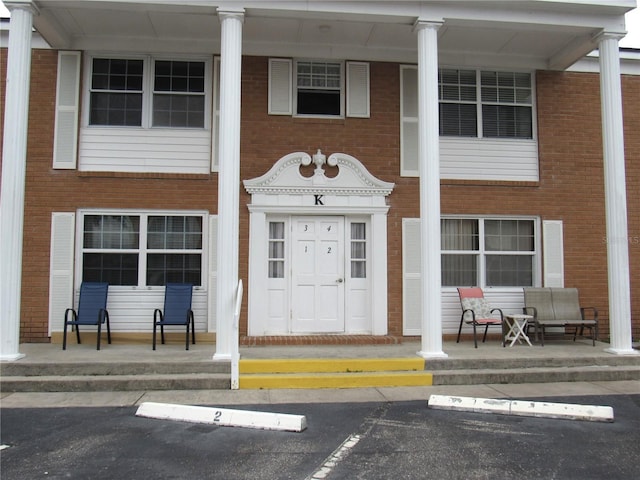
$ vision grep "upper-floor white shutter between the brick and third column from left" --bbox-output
[400,65,420,177]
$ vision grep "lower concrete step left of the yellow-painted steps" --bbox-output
[1,373,231,392]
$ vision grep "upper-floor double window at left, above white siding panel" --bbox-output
[88,57,211,128]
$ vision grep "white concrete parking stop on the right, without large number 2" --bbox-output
[428,395,613,422]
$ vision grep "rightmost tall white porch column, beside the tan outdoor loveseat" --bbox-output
[598,33,638,355]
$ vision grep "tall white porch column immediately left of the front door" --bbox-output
[212,9,244,360]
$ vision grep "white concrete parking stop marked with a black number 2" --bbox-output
[136,402,307,432]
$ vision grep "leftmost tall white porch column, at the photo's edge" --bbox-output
[0,1,37,361]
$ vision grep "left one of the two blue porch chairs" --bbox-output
[62,282,111,350]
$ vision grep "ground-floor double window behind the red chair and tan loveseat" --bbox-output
[440,218,536,287]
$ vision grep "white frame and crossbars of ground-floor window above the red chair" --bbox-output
[440,215,543,290]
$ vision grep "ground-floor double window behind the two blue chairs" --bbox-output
[81,213,204,286]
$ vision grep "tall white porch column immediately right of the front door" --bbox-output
[415,20,447,358]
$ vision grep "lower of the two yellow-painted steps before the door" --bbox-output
[240,371,433,390]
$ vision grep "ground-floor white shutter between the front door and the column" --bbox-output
[402,218,422,336]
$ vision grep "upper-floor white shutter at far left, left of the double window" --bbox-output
[53,51,80,169]
